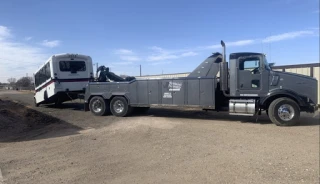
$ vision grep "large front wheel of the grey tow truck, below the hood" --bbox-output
[268,98,300,126]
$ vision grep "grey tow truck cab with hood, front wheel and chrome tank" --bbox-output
[221,49,318,125]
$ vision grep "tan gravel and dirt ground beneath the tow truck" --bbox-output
[0,91,319,184]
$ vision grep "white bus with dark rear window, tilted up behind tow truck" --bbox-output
[34,54,93,106]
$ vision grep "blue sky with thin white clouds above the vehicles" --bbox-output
[0,0,319,82]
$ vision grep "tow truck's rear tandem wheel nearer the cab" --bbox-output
[110,96,132,117]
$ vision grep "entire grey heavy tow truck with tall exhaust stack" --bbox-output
[84,41,318,126]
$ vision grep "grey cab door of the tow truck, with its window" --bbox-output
[237,55,269,96]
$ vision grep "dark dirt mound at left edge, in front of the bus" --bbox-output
[0,100,65,141]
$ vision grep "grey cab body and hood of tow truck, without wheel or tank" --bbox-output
[230,53,318,112]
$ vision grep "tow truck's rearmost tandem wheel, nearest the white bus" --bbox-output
[89,96,109,116]
